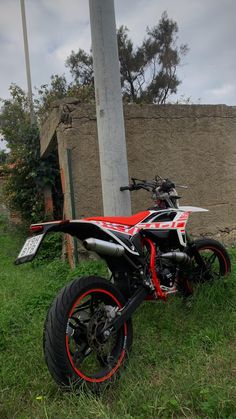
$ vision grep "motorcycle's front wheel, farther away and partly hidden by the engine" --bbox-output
[181,239,231,296]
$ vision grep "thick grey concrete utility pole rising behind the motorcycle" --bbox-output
[89,0,131,215]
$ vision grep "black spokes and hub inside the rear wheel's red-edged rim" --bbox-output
[68,292,125,377]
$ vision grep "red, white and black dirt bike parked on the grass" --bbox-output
[16,177,230,390]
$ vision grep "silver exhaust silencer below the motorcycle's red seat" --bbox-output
[83,237,125,257]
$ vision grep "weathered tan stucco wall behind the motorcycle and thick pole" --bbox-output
[40,101,236,243]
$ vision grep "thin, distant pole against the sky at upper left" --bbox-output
[20,0,35,125]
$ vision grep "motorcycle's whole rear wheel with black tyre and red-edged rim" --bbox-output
[43,276,132,391]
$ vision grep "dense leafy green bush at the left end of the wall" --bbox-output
[1,84,59,222]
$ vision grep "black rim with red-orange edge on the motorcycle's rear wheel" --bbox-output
[66,289,127,382]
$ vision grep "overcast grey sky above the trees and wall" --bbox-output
[0,0,236,105]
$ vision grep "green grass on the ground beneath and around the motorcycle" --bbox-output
[0,225,236,419]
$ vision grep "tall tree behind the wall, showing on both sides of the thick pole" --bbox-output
[66,12,188,103]
